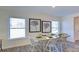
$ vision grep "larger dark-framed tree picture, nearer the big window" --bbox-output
[29,18,41,32]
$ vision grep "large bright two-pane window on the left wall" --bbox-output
[10,18,25,39]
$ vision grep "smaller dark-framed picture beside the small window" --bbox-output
[42,21,51,33]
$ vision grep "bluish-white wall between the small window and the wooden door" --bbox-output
[62,13,79,42]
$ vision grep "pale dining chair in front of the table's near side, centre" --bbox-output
[45,38,59,52]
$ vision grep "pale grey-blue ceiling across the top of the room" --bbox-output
[0,6,79,16]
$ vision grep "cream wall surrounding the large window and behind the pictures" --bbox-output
[0,10,60,49]
